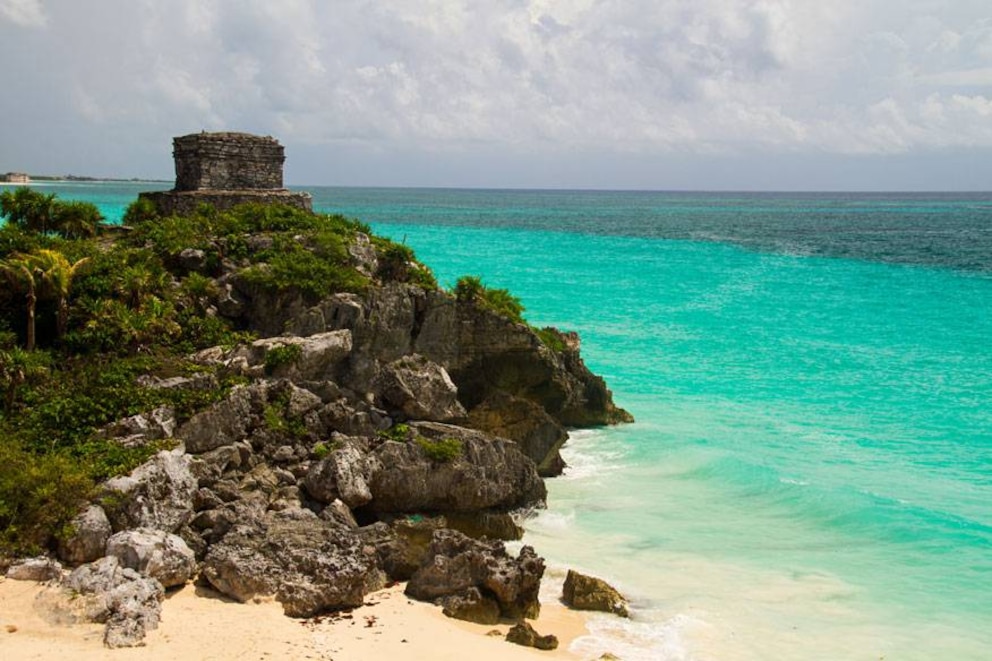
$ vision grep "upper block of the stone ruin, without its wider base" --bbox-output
[172,133,286,191]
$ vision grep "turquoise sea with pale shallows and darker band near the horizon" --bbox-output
[15,184,992,661]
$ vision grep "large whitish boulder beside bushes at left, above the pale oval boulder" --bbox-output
[101,450,197,532]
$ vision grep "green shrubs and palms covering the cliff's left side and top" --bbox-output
[0,188,433,553]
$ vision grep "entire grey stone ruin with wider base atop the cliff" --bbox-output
[138,131,311,216]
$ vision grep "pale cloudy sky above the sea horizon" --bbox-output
[0,0,992,190]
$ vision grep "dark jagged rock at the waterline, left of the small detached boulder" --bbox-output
[406,529,544,619]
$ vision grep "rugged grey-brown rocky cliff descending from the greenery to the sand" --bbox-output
[3,202,630,645]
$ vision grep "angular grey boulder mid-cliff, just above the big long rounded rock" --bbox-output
[376,354,465,422]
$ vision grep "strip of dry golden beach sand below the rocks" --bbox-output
[0,579,586,661]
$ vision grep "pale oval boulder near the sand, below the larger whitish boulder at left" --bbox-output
[107,530,196,588]
